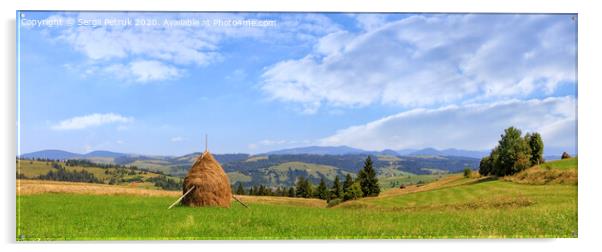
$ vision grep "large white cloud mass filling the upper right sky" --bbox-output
[261,15,576,113]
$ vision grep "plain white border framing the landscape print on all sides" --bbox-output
[0,0,602,252]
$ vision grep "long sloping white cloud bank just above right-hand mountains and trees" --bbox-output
[320,97,577,150]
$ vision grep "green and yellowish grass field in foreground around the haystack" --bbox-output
[17,160,577,240]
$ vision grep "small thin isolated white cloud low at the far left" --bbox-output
[52,113,134,130]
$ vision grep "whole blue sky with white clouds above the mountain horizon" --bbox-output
[19,12,577,155]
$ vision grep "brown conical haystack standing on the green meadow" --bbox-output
[182,151,232,207]
